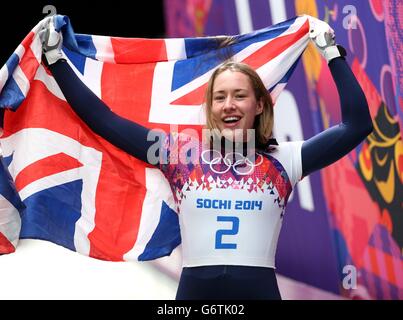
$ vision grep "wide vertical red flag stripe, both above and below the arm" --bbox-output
[88,60,155,260]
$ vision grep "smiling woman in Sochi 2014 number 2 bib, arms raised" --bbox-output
[42,16,372,299]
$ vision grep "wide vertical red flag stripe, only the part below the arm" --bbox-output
[88,160,146,261]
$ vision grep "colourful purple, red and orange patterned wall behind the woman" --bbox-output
[165,0,403,299]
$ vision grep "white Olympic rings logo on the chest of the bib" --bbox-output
[201,150,263,175]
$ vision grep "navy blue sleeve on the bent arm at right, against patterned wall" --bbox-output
[301,57,373,176]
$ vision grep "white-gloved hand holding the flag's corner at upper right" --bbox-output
[309,17,346,63]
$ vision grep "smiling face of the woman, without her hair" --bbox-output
[211,69,263,141]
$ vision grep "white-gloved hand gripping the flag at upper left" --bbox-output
[39,16,64,65]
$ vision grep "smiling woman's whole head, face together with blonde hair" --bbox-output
[204,61,274,149]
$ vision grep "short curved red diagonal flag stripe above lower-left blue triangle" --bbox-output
[15,153,82,191]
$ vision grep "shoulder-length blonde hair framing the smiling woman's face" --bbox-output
[204,61,274,148]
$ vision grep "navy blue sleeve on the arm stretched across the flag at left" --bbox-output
[49,60,164,165]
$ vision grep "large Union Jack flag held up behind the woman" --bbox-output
[0,16,309,261]
